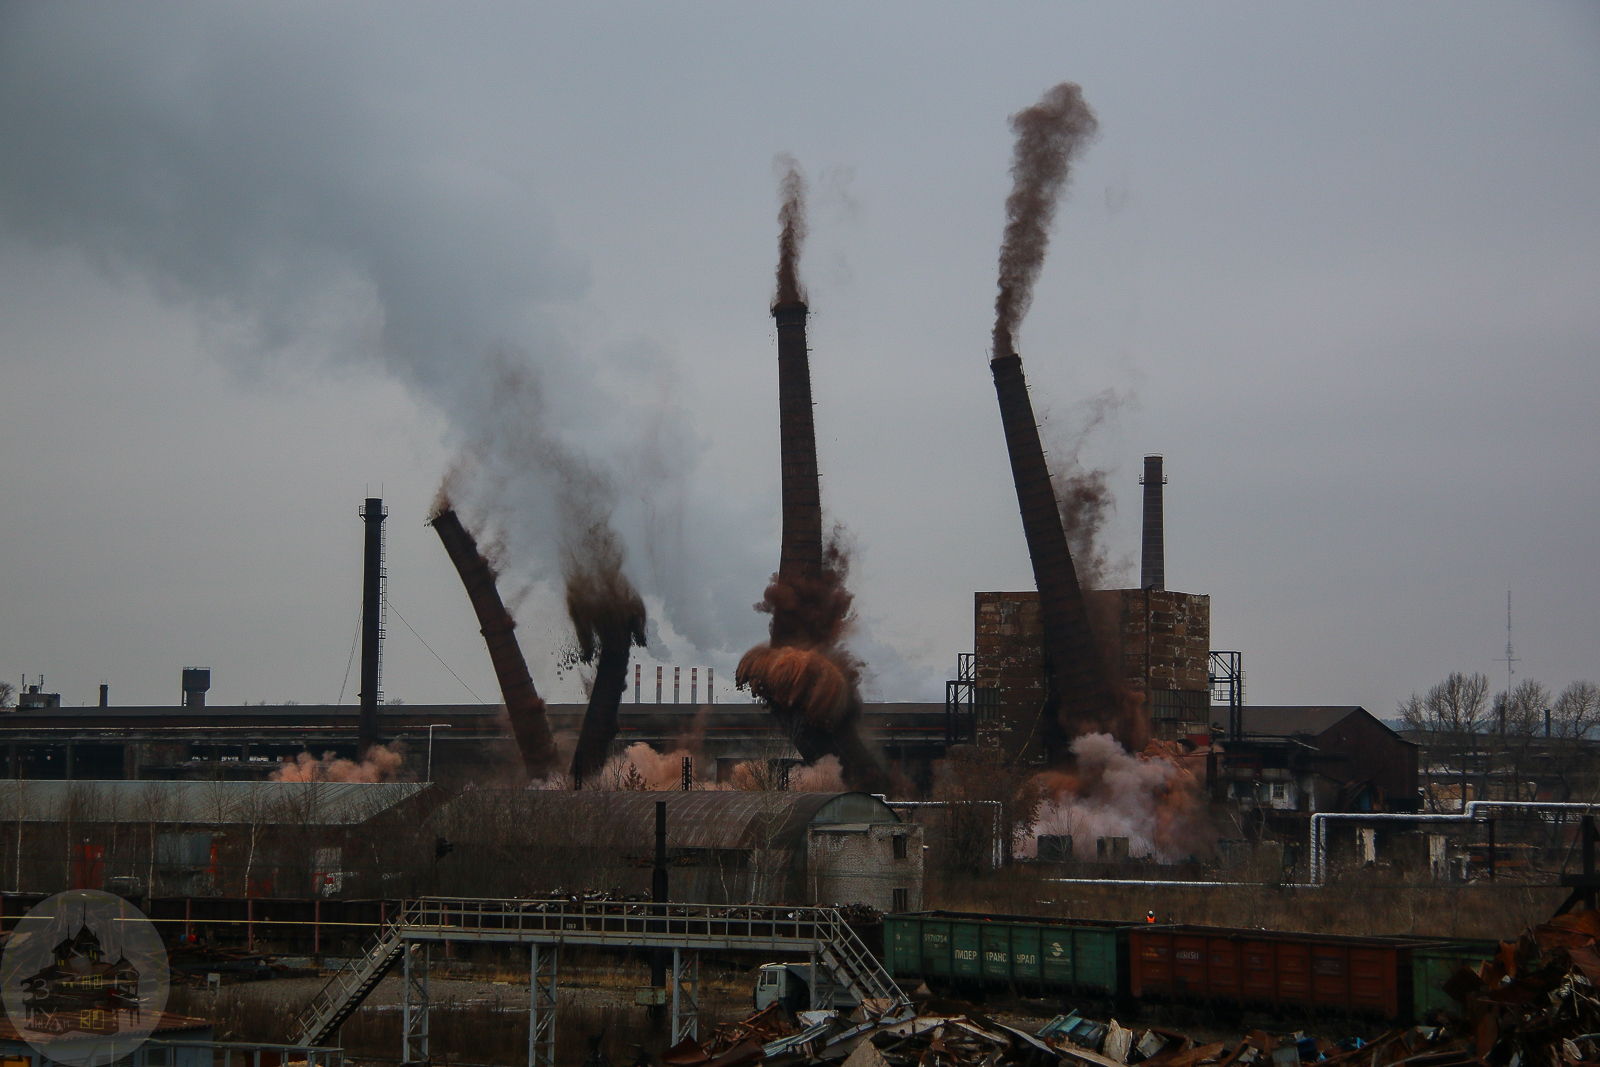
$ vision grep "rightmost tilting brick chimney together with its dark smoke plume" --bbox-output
[989,83,1117,763]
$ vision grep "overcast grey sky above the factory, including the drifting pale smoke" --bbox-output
[0,3,1600,715]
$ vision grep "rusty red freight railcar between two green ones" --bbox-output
[1128,926,1419,1019]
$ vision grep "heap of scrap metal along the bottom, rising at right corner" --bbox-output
[662,910,1600,1067]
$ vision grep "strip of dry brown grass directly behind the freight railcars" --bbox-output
[925,867,1566,939]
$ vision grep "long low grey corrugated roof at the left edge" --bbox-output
[0,779,427,825]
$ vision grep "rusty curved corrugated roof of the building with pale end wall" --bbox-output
[464,789,901,853]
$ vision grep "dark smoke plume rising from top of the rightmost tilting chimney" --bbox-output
[994,82,1099,355]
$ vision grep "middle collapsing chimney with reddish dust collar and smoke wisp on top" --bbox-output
[734,160,890,790]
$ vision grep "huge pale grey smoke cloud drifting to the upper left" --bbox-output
[0,5,770,684]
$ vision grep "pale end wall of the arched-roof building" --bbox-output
[806,822,922,912]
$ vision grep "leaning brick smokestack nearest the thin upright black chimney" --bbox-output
[432,506,555,777]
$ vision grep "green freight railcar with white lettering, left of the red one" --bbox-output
[883,912,1126,997]
